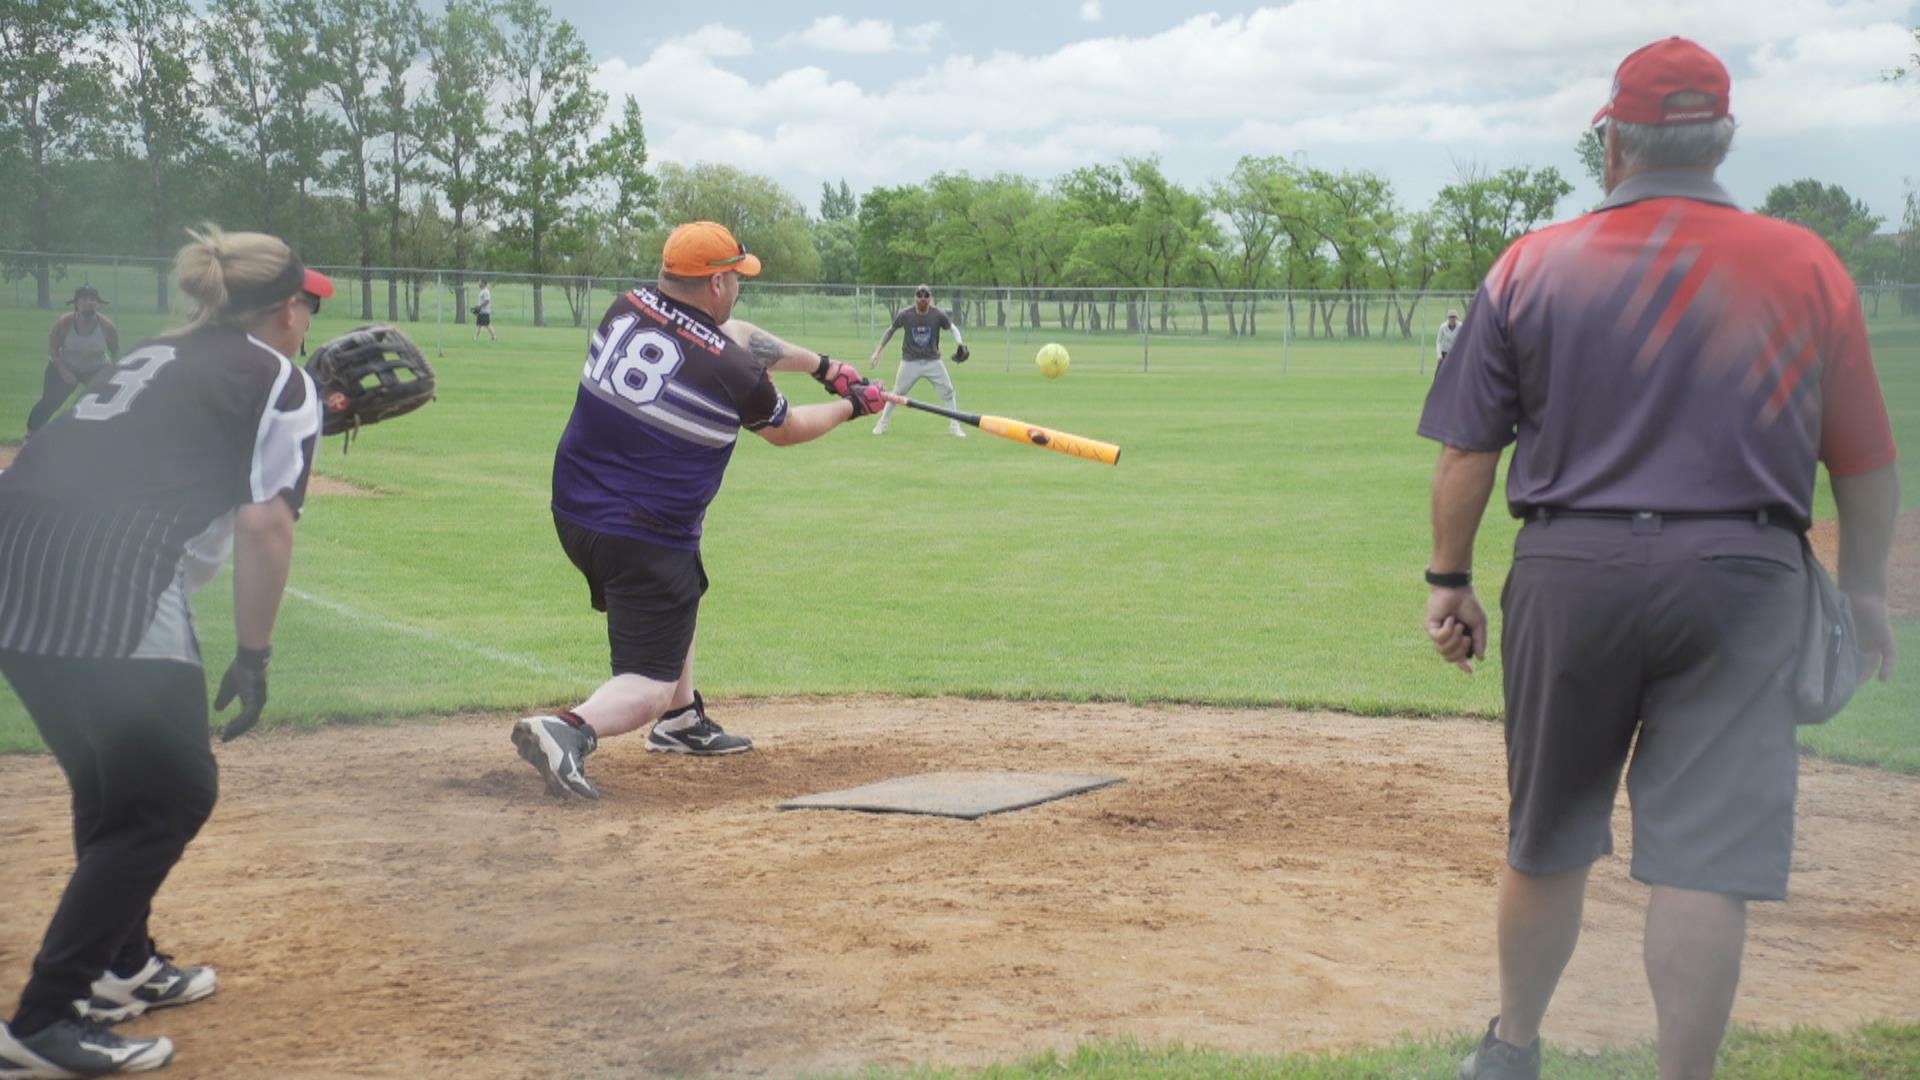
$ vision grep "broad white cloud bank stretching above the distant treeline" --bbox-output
[597,0,1920,220]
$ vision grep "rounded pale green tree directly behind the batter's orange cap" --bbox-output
[649,163,820,281]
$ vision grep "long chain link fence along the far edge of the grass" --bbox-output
[0,250,1920,369]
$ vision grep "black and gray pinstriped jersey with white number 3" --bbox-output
[0,327,321,663]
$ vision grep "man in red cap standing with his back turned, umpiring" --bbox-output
[1419,38,1899,1080]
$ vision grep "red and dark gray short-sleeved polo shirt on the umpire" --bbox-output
[1419,171,1895,523]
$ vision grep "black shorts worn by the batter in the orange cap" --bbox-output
[553,515,707,682]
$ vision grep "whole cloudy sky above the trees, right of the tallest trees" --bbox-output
[551,0,1920,221]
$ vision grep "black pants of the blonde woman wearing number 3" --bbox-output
[0,653,219,1036]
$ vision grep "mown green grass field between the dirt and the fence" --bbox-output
[0,297,1920,760]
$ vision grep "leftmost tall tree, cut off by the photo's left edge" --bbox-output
[0,0,109,307]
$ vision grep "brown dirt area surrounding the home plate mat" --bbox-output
[0,700,1920,1078]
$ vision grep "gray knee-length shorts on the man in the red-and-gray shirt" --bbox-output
[1500,517,1805,899]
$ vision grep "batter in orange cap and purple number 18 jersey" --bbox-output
[513,221,883,799]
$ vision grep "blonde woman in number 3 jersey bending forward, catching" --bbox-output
[0,227,334,1076]
